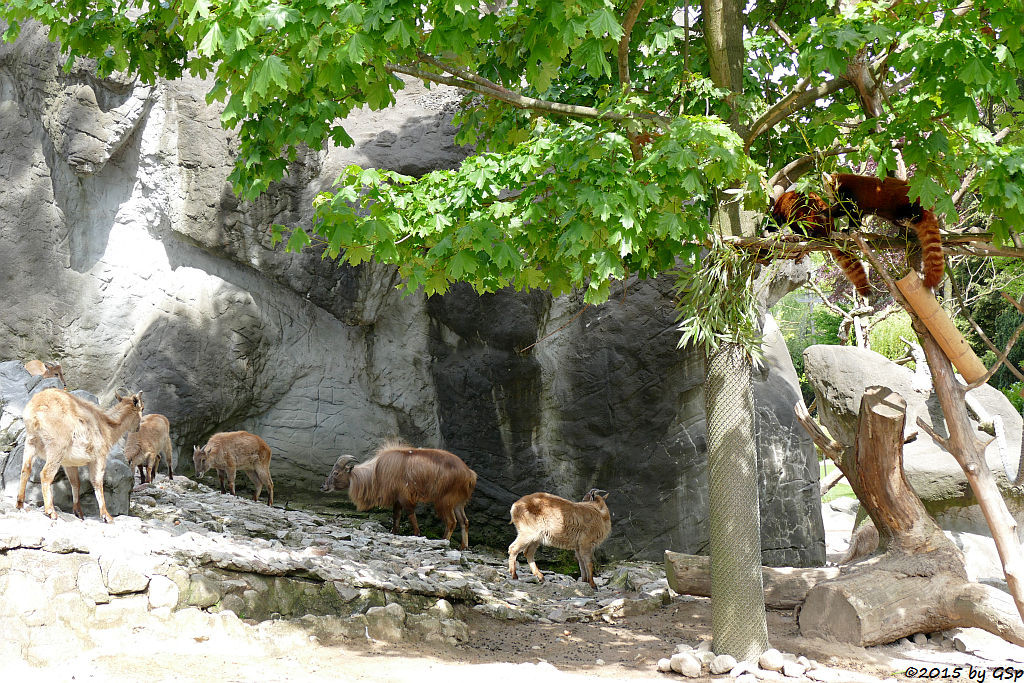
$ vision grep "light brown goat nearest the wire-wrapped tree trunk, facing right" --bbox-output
[509,488,611,588]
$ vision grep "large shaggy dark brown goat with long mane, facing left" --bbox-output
[321,442,476,550]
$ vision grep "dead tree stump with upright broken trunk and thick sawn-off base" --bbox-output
[800,387,1024,645]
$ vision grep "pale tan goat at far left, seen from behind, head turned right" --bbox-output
[16,389,143,522]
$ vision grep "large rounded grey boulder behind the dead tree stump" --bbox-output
[804,345,1024,535]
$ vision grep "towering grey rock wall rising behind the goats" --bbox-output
[0,25,824,565]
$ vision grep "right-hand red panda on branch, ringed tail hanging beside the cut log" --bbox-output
[826,173,945,289]
